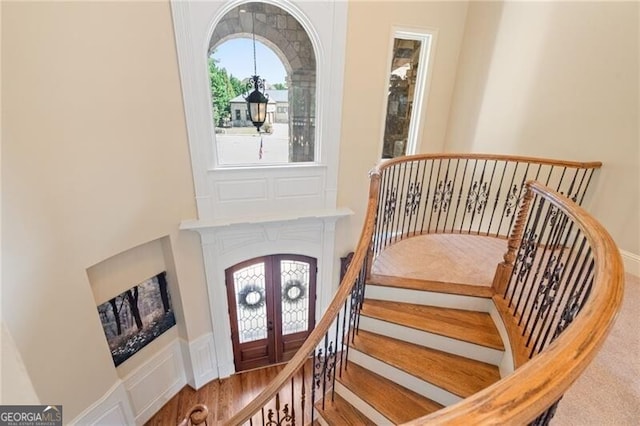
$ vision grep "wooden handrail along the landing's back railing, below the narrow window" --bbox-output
[374,153,602,173]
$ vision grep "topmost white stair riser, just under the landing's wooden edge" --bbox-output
[365,284,493,312]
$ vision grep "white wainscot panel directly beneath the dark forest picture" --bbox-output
[123,339,187,425]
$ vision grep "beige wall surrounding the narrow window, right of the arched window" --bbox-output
[336,1,467,256]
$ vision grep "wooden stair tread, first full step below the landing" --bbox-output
[361,299,504,350]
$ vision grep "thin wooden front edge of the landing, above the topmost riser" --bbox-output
[367,275,493,298]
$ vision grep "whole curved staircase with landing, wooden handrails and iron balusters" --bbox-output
[221,154,624,426]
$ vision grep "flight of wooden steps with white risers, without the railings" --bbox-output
[315,276,504,425]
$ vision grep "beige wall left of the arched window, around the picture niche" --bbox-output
[2,2,210,420]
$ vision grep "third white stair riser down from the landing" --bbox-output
[347,348,462,406]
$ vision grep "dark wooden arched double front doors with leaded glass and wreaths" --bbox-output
[225,254,316,371]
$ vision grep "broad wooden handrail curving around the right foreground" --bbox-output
[406,182,624,425]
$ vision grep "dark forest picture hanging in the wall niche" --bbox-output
[98,271,176,367]
